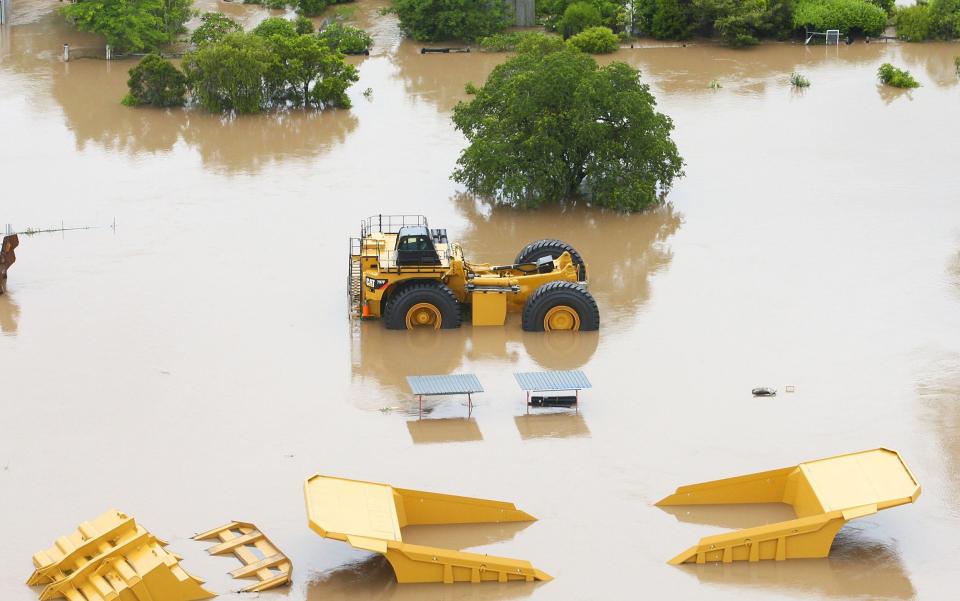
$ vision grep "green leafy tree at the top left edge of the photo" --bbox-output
[60,0,192,52]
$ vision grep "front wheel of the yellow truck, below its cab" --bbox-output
[384,282,460,330]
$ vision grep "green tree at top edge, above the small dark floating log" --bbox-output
[389,0,513,42]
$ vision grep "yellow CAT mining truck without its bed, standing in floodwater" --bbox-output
[347,215,600,332]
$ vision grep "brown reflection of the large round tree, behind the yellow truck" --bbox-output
[454,194,683,326]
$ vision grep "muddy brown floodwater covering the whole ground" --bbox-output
[0,0,960,601]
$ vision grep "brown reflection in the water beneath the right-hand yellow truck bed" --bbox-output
[678,526,916,599]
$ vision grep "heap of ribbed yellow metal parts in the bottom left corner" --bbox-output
[27,510,215,601]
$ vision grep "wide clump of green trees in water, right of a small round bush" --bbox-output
[174,17,357,113]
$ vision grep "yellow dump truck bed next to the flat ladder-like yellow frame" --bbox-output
[305,475,551,583]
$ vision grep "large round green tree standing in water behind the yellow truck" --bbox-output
[453,35,683,211]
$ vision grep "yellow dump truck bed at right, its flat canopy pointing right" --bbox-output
[657,449,920,564]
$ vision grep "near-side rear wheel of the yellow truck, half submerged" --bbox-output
[523,282,600,332]
